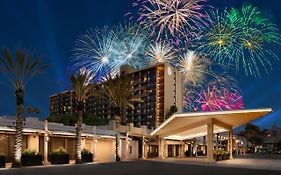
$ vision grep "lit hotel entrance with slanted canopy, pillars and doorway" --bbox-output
[151,108,272,162]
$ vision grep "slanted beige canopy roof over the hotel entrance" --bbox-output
[151,108,272,140]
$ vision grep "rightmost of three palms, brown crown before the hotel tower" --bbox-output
[94,75,143,161]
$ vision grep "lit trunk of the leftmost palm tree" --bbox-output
[13,90,24,167]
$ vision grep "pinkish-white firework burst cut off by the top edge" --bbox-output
[133,0,206,40]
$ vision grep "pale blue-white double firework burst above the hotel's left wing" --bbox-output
[74,25,149,80]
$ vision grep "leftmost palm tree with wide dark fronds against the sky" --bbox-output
[0,48,47,167]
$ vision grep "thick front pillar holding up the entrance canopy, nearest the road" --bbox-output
[207,120,214,162]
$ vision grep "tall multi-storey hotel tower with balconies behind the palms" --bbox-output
[50,63,183,129]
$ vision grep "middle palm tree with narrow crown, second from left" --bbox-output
[70,69,93,163]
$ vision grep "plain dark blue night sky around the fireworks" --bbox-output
[0,0,281,127]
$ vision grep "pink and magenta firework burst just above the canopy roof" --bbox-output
[184,76,244,111]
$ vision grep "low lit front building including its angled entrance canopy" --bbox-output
[0,108,264,162]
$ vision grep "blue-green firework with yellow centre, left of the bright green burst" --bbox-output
[195,11,241,65]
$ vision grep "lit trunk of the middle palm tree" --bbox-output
[76,109,83,164]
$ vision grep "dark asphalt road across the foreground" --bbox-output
[0,160,281,175]
